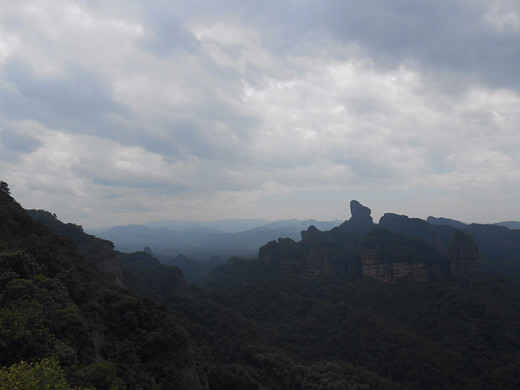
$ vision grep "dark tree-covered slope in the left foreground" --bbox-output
[0,183,202,389]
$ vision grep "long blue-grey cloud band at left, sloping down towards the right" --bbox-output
[0,54,254,165]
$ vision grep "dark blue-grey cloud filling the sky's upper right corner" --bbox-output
[319,0,520,89]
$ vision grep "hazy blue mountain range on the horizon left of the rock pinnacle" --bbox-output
[89,219,342,260]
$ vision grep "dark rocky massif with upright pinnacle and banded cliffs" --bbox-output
[259,200,480,283]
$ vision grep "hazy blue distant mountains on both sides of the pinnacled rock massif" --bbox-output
[90,212,520,281]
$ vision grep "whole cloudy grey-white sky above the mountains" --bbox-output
[0,0,520,228]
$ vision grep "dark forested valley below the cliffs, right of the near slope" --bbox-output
[171,260,520,389]
